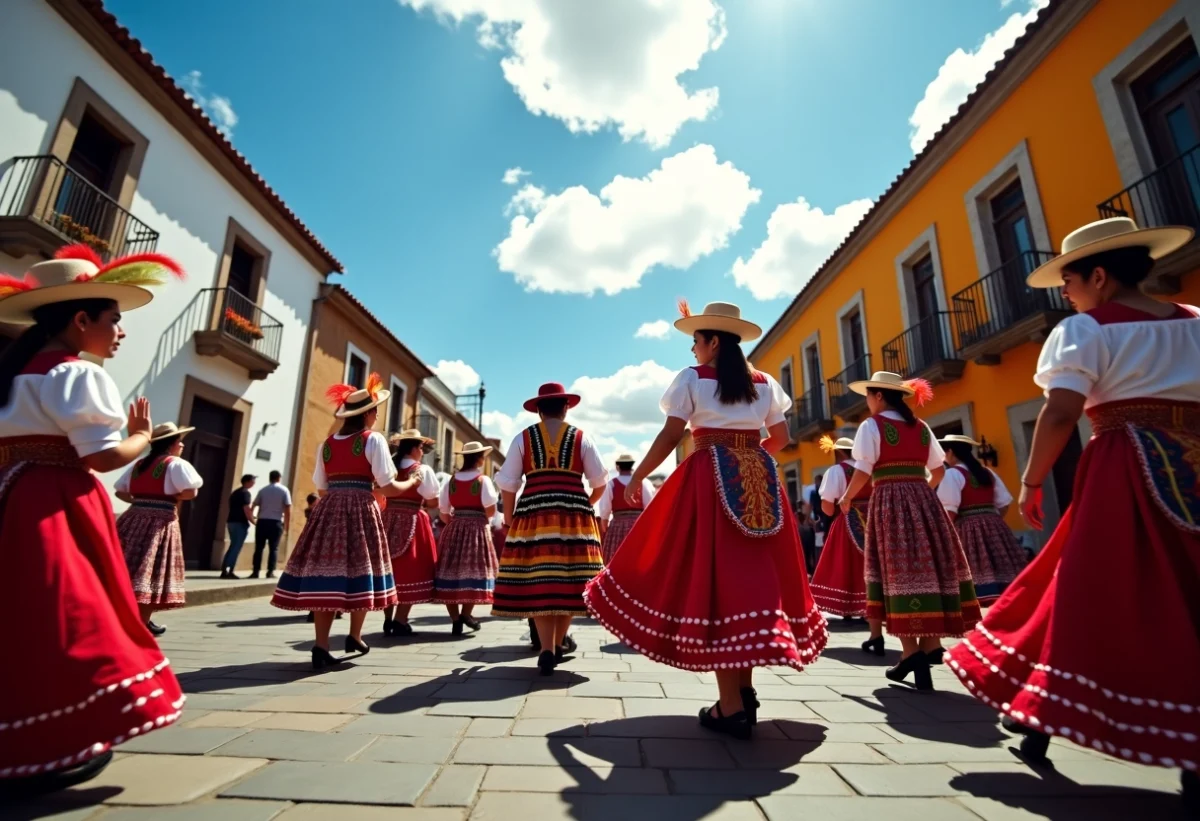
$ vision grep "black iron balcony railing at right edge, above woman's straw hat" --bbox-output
[1096,145,1200,229]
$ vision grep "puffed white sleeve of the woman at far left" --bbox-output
[40,361,125,456]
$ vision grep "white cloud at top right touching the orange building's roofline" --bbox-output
[908,0,1050,154]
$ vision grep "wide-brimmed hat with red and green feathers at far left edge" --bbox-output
[0,245,184,325]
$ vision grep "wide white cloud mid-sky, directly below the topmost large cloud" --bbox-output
[494,144,762,294]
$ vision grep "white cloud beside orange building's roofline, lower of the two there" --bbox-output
[732,197,871,299]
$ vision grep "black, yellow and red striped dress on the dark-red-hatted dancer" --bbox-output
[492,423,604,618]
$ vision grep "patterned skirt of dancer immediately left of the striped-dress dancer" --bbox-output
[433,510,498,604]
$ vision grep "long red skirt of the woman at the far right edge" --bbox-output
[948,400,1200,771]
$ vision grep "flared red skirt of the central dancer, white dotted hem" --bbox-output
[583,436,828,670]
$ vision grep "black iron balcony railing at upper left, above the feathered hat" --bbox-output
[0,155,158,259]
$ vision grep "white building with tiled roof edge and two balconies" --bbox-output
[0,0,341,568]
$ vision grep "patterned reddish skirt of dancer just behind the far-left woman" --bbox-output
[116,504,185,610]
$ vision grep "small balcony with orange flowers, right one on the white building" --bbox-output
[194,288,283,379]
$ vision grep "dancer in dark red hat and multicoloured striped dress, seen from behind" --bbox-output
[492,382,607,676]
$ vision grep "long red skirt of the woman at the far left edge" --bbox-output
[0,463,184,778]
